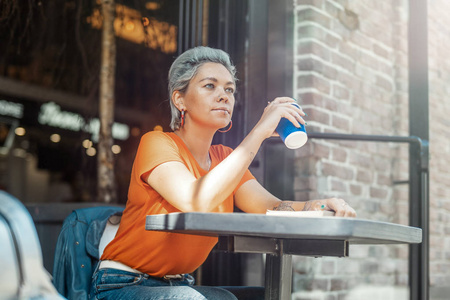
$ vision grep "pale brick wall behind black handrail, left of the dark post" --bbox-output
[293,0,420,300]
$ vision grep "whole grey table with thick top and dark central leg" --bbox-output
[145,212,422,300]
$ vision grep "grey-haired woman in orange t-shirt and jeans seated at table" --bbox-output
[93,47,355,299]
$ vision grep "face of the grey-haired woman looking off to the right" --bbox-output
[183,63,236,130]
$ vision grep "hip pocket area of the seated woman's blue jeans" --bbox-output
[95,270,144,293]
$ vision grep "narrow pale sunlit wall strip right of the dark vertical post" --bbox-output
[428,0,450,290]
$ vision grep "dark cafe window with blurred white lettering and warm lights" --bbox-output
[0,0,179,203]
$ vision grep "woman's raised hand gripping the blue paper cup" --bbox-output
[253,97,306,139]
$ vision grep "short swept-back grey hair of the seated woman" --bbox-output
[169,46,237,131]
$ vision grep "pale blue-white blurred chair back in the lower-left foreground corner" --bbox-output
[0,191,64,299]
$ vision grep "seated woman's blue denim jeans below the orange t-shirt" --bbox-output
[91,269,264,300]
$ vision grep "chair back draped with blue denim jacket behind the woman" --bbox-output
[53,206,123,299]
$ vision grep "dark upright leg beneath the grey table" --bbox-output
[264,253,292,300]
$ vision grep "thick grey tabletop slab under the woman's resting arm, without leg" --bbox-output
[146,212,422,244]
